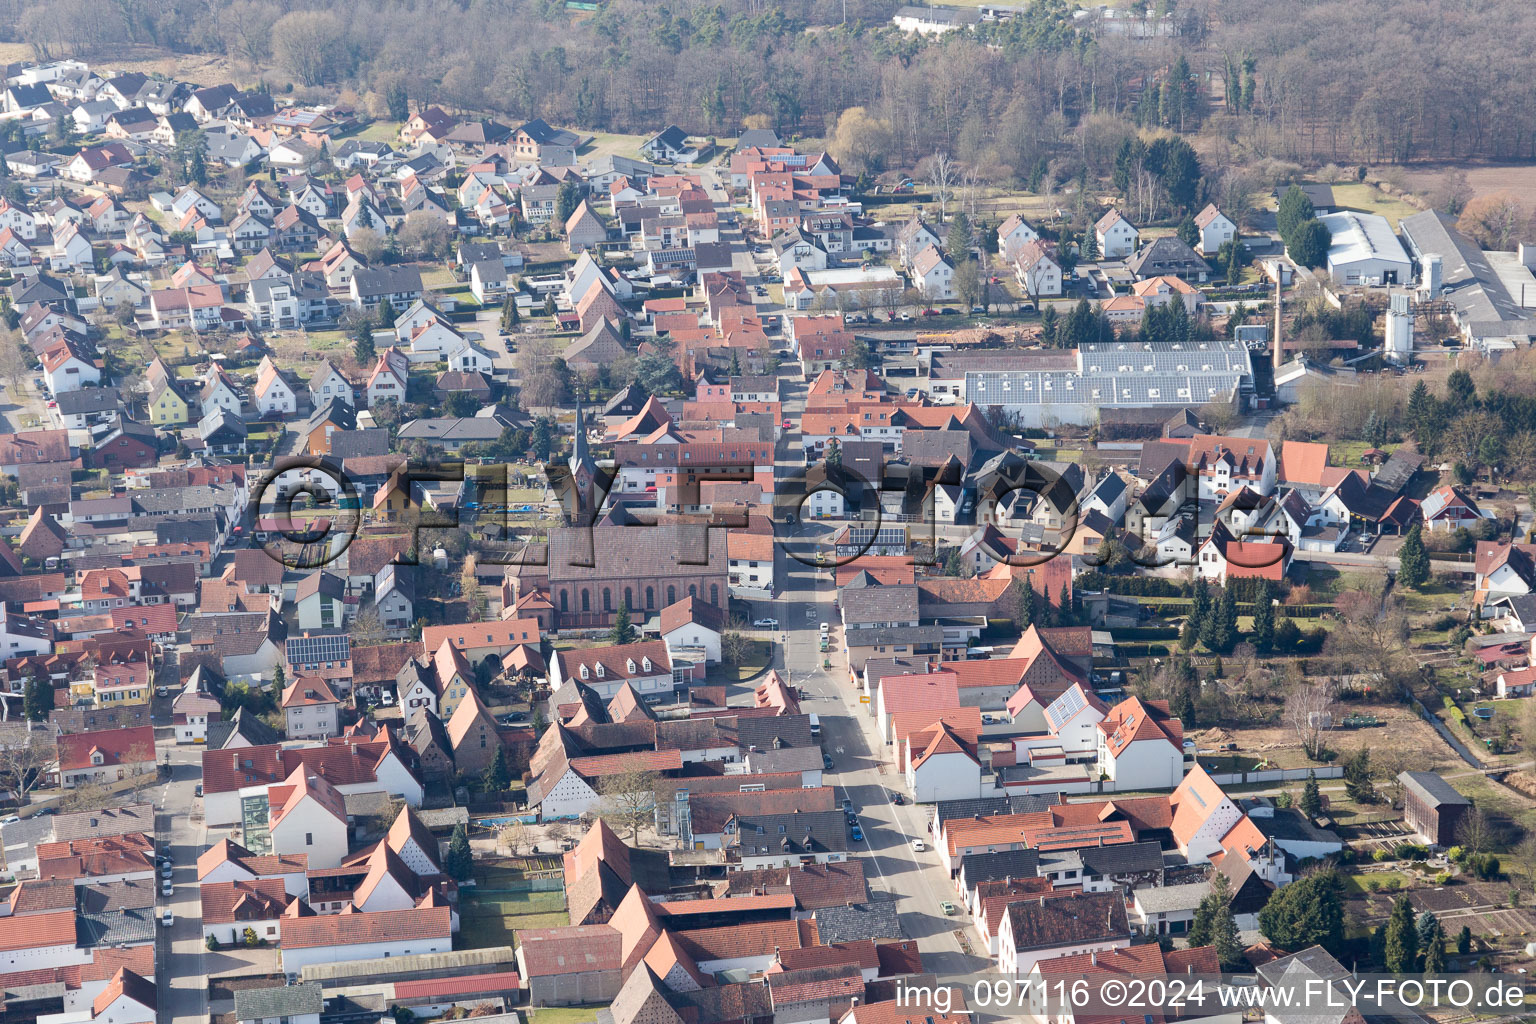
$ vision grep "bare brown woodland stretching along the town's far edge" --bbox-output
[0,0,1536,183]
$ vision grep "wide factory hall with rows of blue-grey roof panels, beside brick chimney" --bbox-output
[958,339,1253,427]
